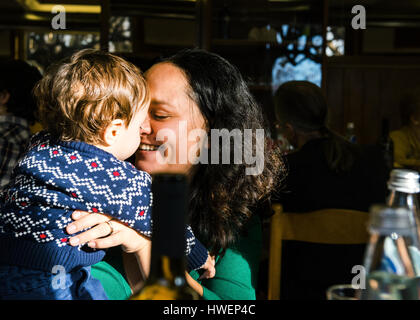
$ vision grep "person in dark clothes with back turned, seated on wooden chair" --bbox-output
[273,81,387,300]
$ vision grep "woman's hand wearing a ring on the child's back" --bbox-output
[66,211,151,253]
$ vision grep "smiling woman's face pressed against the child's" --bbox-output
[136,63,206,174]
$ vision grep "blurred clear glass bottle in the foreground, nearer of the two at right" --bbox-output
[361,206,420,300]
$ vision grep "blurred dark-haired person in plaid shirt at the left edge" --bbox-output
[0,60,42,190]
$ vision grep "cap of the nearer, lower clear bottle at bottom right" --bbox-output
[369,205,416,234]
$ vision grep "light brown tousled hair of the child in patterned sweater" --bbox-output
[34,49,150,144]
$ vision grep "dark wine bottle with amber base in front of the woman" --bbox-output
[130,173,199,300]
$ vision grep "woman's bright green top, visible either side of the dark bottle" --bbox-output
[92,216,262,300]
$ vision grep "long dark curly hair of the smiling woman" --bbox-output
[163,49,284,254]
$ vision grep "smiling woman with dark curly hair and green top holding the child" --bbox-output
[65,50,282,299]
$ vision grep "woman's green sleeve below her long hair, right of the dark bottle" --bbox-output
[190,216,262,300]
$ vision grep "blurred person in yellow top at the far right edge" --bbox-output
[390,88,420,171]
